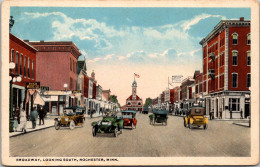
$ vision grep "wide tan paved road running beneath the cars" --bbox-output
[10,114,250,157]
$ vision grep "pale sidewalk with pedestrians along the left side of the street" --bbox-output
[9,115,58,137]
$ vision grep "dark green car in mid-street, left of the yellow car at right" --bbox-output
[149,110,169,126]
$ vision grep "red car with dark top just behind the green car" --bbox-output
[122,110,137,129]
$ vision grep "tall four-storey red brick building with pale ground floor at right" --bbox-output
[200,17,251,118]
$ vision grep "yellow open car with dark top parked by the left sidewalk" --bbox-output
[54,106,85,130]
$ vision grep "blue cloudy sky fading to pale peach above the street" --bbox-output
[10,7,251,105]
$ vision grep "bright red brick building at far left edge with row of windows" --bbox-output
[9,33,38,114]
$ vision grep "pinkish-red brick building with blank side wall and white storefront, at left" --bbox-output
[24,40,81,114]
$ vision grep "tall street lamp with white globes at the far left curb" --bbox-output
[9,62,22,132]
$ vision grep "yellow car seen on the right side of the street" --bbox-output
[183,106,208,129]
